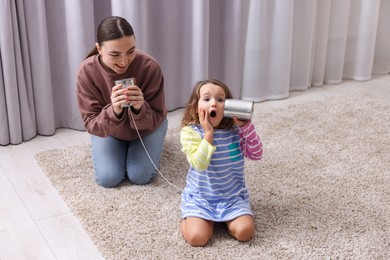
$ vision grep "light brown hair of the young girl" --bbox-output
[181,79,234,129]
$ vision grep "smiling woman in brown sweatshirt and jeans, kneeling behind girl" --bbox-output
[77,16,168,188]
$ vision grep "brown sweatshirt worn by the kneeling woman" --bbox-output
[76,50,167,141]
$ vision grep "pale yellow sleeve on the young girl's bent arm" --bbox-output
[180,126,216,171]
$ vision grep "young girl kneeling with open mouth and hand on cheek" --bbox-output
[180,80,263,246]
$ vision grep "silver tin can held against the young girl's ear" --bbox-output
[223,99,254,120]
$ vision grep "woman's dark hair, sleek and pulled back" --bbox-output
[86,16,134,58]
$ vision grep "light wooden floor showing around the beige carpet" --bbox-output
[0,75,390,260]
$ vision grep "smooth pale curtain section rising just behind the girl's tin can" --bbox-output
[241,0,294,102]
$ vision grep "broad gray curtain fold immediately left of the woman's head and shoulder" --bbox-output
[45,0,95,129]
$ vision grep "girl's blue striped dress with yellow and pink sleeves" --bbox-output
[180,121,263,222]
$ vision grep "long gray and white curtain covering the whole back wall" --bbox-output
[0,0,390,145]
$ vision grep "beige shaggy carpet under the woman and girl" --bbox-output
[36,94,390,259]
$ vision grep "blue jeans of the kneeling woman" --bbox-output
[91,119,168,188]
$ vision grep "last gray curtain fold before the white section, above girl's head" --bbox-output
[210,0,249,98]
